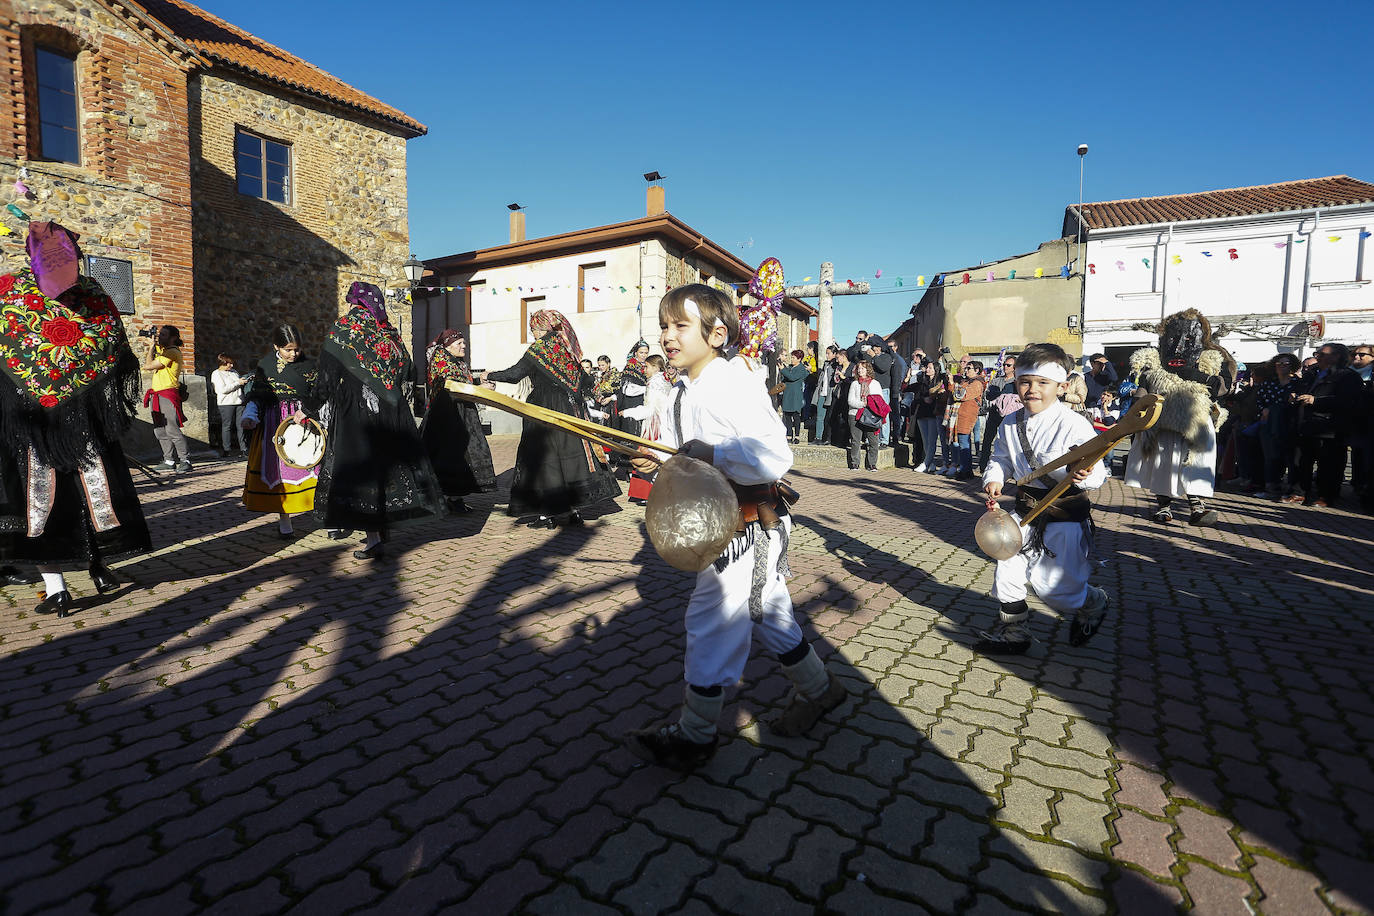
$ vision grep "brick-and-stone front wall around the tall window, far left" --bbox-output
[0,0,195,357]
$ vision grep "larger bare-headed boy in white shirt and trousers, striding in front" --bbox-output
[625,283,846,770]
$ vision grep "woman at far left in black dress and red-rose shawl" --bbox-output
[0,222,153,617]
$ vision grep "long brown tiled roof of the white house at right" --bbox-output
[1063,174,1374,236]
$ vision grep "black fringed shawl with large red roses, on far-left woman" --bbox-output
[0,269,139,468]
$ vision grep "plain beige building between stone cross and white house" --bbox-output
[900,239,1083,364]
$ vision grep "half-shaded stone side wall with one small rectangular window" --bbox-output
[190,73,411,372]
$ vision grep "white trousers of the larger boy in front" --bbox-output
[686,516,801,687]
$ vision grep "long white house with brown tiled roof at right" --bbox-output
[1063,174,1374,365]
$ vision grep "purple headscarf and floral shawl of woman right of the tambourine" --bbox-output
[320,282,411,404]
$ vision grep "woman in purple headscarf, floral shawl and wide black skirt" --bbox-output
[315,282,444,560]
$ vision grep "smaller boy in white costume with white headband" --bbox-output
[976,343,1109,655]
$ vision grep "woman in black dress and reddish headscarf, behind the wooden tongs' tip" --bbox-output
[420,328,496,512]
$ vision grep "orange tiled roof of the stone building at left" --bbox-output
[132,0,429,136]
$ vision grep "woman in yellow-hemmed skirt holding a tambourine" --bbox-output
[239,324,320,538]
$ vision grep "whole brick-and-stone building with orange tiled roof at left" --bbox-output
[0,0,426,441]
